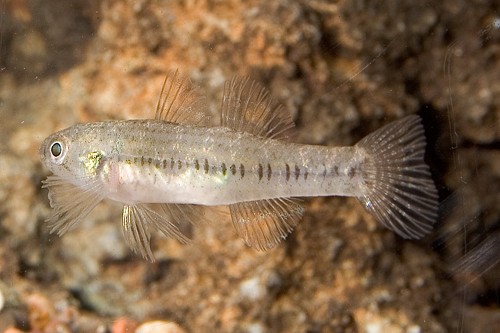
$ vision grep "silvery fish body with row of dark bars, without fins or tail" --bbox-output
[41,119,366,206]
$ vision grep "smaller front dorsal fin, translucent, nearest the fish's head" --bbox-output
[155,70,210,126]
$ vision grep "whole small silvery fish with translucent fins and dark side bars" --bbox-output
[39,71,438,261]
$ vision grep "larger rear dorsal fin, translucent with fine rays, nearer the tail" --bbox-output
[222,76,294,139]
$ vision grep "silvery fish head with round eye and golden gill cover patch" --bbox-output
[38,124,105,186]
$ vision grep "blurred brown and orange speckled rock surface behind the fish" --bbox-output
[0,0,500,333]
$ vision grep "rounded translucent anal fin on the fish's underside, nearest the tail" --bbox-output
[229,198,304,251]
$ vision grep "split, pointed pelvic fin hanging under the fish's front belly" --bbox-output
[122,204,190,262]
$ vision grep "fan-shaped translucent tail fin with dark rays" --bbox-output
[356,116,438,238]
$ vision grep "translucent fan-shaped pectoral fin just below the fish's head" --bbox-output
[42,175,105,236]
